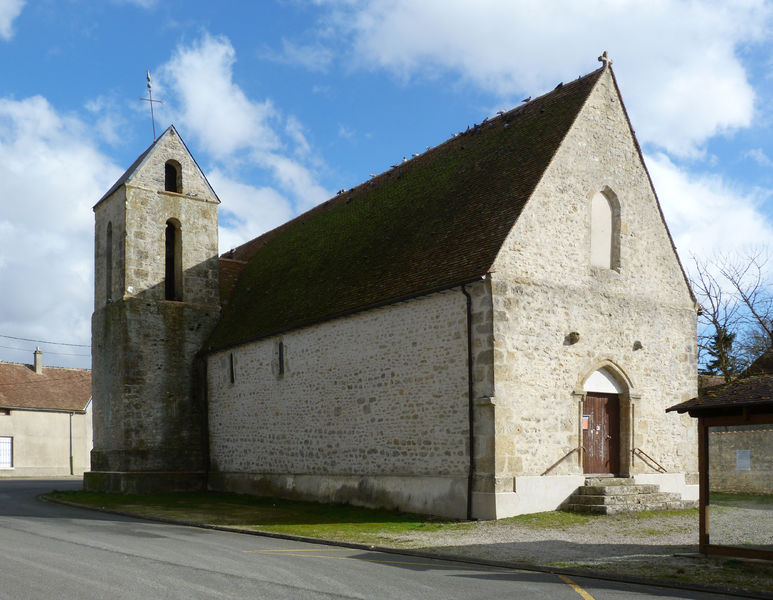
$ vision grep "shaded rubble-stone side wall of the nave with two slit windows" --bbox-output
[207,289,469,477]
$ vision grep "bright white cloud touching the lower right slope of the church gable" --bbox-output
[646,153,773,263]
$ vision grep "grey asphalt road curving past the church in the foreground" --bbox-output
[0,479,748,600]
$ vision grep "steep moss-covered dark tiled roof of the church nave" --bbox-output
[205,69,603,350]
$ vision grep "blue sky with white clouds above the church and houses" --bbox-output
[0,0,773,367]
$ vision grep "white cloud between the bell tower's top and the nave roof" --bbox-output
[160,34,330,249]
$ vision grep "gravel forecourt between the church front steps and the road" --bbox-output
[366,508,773,597]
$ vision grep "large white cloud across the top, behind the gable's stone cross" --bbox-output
[322,0,773,156]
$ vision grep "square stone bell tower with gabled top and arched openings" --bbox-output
[84,127,220,493]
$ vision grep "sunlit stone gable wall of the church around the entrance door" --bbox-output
[492,72,697,491]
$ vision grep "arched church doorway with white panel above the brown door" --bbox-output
[581,367,627,475]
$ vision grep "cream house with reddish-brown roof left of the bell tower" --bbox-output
[0,350,92,477]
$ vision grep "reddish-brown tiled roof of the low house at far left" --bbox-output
[0,362,91,411]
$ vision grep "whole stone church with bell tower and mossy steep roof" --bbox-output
[85,62,697,519]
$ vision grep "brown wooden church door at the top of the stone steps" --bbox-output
[582,392,620,475]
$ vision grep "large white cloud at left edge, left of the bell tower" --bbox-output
[0,96,121,366]
